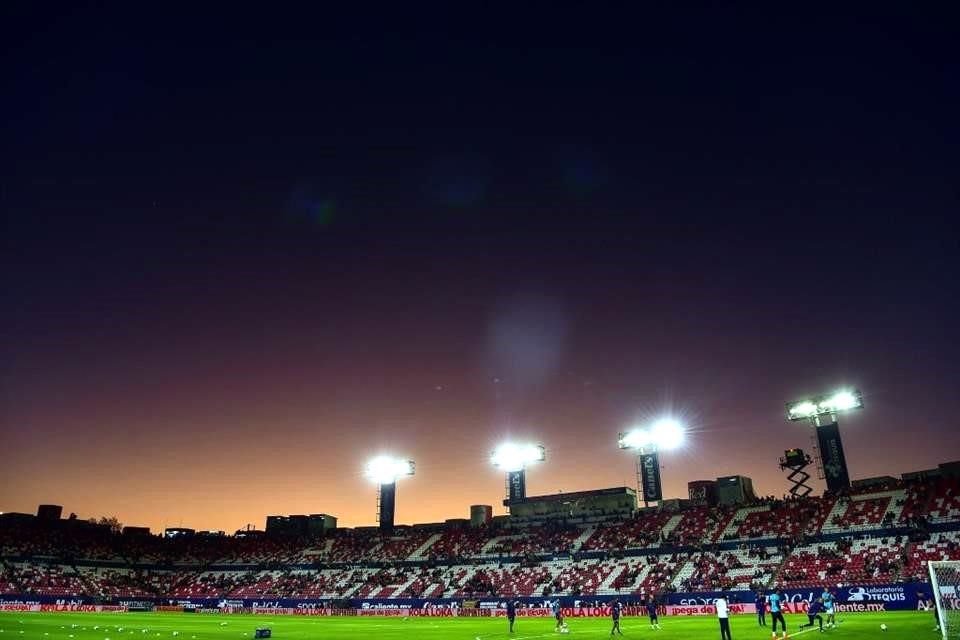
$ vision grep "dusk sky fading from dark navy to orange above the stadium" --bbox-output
[0,7,960,531]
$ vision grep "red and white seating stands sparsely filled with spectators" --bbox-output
[0,477,960,606]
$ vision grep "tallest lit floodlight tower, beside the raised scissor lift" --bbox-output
[787,389,863,493]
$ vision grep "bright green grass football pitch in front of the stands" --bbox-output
[0,611,940,640]
